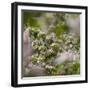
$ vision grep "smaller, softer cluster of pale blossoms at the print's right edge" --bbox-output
[59,33,80,53]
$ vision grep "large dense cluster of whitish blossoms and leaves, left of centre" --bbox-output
[30,29,59,64]
